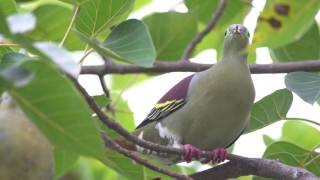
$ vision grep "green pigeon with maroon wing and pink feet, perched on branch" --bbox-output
[119,24,255,164]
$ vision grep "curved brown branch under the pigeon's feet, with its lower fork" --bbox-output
[70,77,317,179]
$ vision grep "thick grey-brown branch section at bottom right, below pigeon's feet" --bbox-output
[191,157,319,180]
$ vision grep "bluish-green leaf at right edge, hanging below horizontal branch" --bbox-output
[285,72,320,104]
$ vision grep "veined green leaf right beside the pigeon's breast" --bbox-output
[246,89,292,133]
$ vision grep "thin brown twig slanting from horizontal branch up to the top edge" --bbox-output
[181,0,227,61]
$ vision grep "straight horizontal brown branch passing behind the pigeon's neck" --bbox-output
[81,60,320,75]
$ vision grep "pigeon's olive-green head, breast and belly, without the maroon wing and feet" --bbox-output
[134,25,255,162]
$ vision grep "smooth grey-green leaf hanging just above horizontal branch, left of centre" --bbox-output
[102,19,156,67]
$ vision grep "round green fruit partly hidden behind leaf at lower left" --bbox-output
[0,97,53,180]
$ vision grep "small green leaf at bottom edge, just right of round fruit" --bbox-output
[53,148,79,179]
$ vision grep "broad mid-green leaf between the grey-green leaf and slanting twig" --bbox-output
[143,12,197,60]
